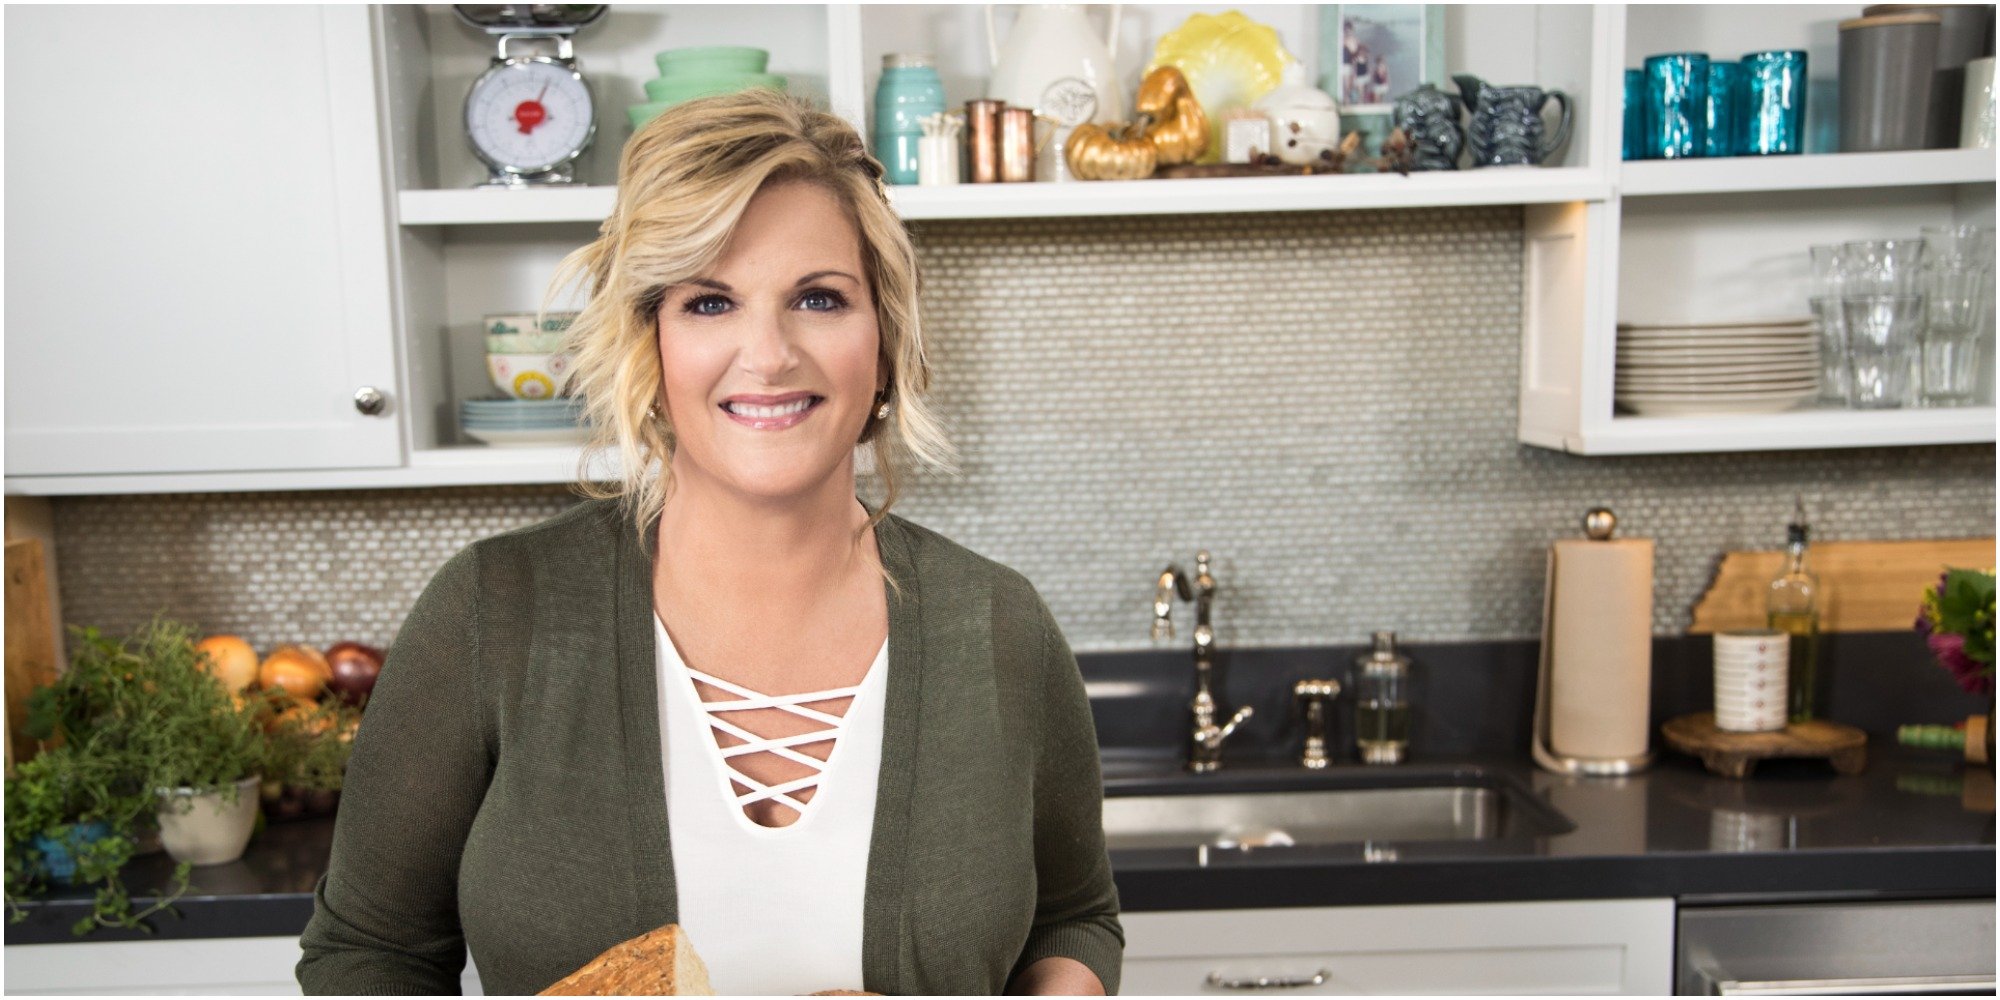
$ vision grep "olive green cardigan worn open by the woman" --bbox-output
[298,500,1124,994]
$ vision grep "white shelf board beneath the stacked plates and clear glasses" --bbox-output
[1532,406,1994,454]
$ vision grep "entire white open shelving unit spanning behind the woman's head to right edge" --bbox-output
[378,4,1994,484]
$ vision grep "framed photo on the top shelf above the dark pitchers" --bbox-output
[1318,4,1444,167]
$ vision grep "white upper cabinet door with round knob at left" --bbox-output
[6,6,402,480]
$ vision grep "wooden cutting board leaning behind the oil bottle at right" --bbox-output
[1688,538,1994,632]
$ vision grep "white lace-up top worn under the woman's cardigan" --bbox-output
[654,616,888,996]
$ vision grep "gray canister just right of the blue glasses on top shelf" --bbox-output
[1840,14,1942,152]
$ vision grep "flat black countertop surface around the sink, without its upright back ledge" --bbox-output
[6,742,1994,944]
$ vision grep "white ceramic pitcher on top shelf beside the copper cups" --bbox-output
[986,4,1126,124]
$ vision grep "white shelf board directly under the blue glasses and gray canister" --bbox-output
[1618,150,1994,198]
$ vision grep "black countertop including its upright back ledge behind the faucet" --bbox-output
[6,634,1994,944]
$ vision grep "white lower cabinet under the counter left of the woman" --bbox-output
[6,938,482,996]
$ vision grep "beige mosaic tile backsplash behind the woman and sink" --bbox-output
[56,208,1994,650]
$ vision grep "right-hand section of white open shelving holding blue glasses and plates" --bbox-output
[1518,4,1994,456]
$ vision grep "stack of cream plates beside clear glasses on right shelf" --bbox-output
[1612,318,1820,416]
